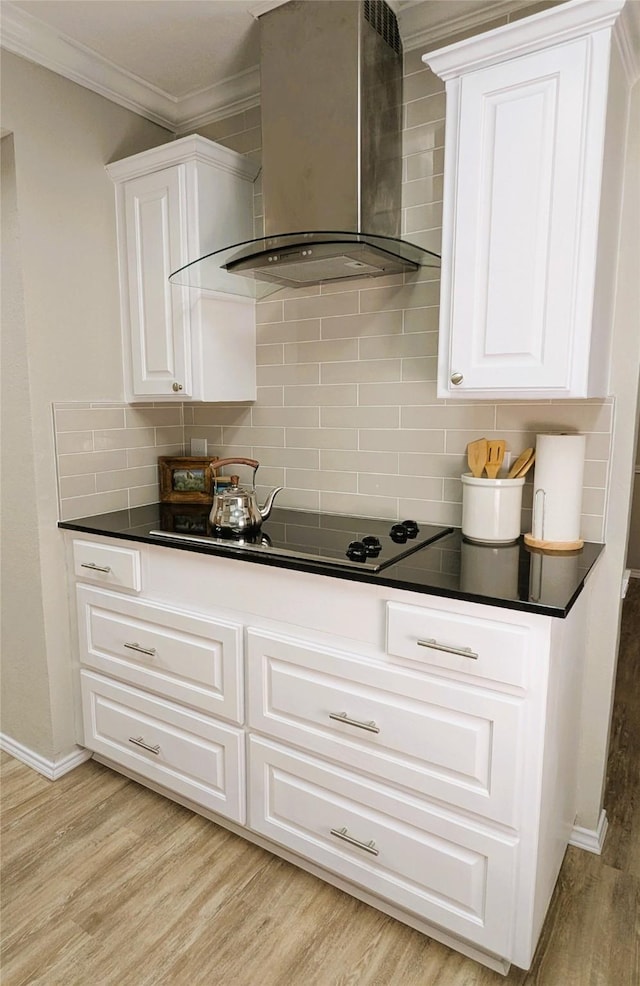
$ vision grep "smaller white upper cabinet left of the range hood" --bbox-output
[107,136,257,402]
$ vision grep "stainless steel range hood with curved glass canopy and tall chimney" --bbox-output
[170,0,440,296]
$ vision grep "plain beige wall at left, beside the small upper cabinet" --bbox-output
[0,51,170,761]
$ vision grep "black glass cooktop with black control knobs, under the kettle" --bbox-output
[149,504,452,572]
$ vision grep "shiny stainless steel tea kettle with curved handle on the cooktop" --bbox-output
[209,459,284,537]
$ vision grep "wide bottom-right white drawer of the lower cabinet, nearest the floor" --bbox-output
[249,737,517,955]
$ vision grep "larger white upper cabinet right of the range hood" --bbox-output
[423,0,630,400]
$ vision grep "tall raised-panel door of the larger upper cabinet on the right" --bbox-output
[440,38,597,397]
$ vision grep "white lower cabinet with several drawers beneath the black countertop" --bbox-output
[69,538,588,972]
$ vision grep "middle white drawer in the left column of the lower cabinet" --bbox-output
[76,585,244,723]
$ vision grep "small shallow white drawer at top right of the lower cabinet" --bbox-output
[387,603,529,688]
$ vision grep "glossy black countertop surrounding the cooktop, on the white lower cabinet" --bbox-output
[58,503,604,617]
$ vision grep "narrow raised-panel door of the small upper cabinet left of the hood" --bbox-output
[124,165,192,400]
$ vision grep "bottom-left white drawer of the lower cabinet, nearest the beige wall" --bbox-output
[80,671,245,824]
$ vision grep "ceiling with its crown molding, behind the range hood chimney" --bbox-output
[5,0,636,134]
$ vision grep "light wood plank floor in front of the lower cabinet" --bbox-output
[1,580,640,986]
